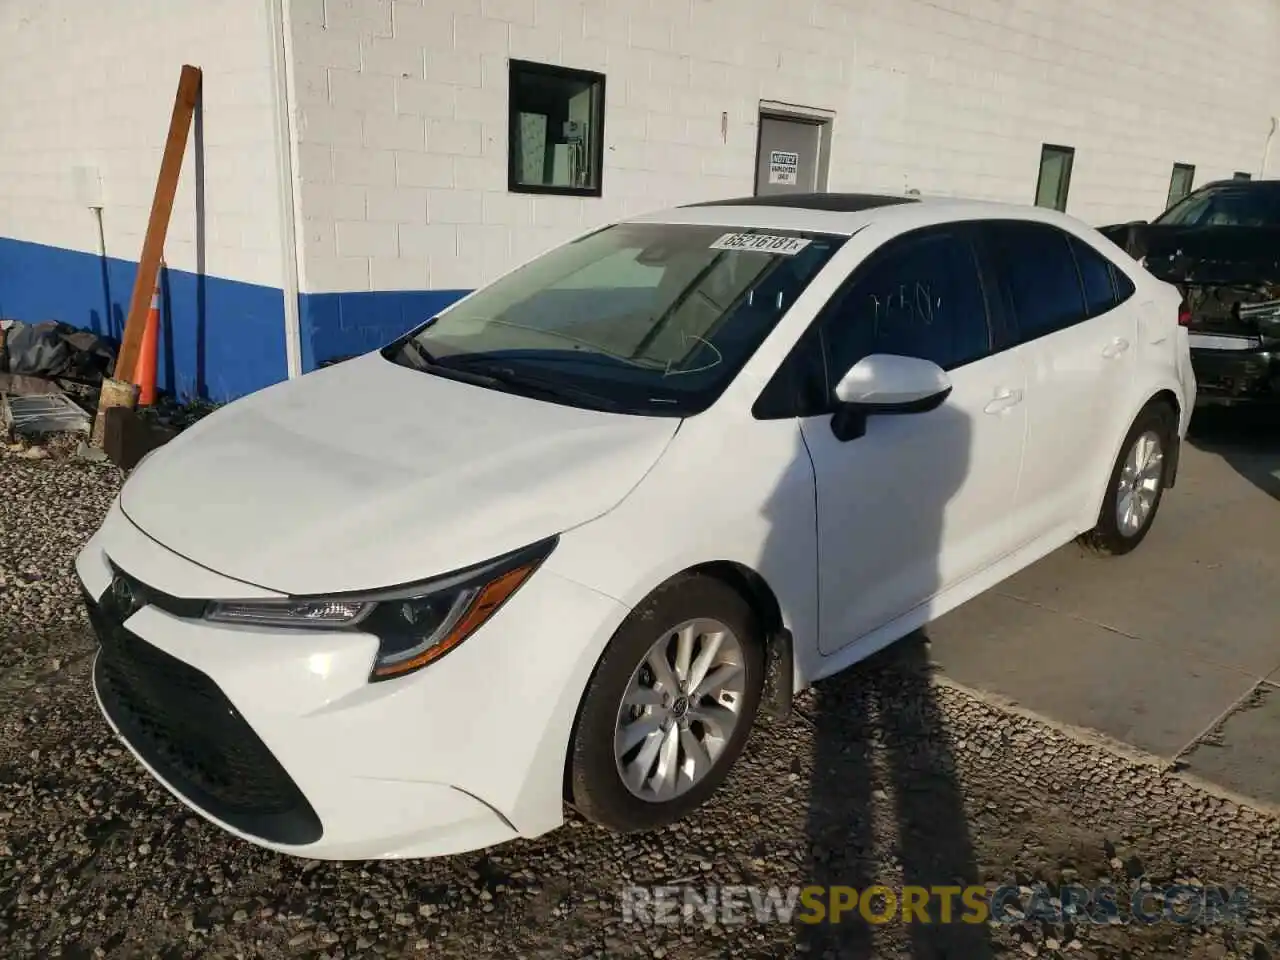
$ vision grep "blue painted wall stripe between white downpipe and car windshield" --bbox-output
[298,291,470,370]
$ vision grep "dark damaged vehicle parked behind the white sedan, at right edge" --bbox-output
[1101,180,1280,404]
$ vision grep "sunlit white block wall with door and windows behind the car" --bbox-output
[292,0,1280,292]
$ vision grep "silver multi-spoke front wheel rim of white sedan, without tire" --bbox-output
[613,618,746,803]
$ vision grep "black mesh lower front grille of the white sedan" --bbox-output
[84,590,323,845]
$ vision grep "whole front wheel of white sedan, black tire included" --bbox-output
[567,575,764,833]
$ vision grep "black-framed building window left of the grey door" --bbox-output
[507,60,604,197]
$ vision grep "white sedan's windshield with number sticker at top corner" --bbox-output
[383,223,845,416]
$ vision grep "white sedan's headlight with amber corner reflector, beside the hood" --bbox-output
[205,538,557,681]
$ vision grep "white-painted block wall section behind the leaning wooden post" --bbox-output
[0,0,285,287]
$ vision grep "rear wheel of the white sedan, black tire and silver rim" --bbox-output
[1082,403,1178,556]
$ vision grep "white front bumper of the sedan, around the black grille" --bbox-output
[77,508,626,860]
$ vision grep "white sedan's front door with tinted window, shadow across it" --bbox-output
[773,225,1025,654]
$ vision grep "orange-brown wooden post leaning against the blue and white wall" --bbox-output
[90,64,201,447]
